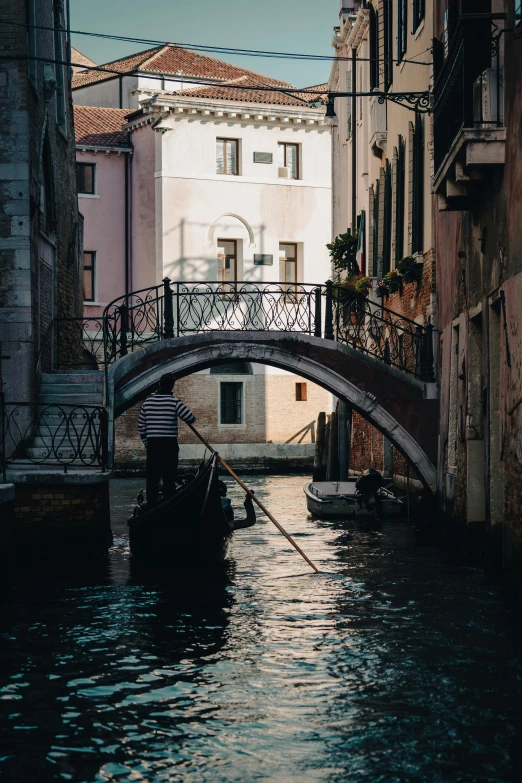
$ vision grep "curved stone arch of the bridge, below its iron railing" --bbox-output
[107,332,438,493]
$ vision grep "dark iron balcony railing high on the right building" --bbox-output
[433,14,504,174]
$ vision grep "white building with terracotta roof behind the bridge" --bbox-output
[73,46,332,466]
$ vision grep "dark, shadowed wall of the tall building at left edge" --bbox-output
[0,0,83,400]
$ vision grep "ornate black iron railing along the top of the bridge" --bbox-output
[99,278,433,381]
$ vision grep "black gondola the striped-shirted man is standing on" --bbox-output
[128,452,234,569]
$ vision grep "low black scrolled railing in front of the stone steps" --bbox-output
[0,396,108,480]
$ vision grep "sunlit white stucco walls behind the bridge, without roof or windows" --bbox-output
[74,52,331,468]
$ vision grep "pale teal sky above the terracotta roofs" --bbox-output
[70,0,340,87]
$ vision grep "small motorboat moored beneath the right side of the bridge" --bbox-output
[304,480,405,518]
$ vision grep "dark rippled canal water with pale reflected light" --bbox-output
[0,476,522,783]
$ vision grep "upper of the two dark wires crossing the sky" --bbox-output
[0,19,432,65]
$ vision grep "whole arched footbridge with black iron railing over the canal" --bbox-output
[52,278,438,492]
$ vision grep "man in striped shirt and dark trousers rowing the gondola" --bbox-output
[138,373,196,505]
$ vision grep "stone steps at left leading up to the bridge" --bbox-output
[27,370,104,467]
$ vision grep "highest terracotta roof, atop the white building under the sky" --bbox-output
[72,44,292,89]
